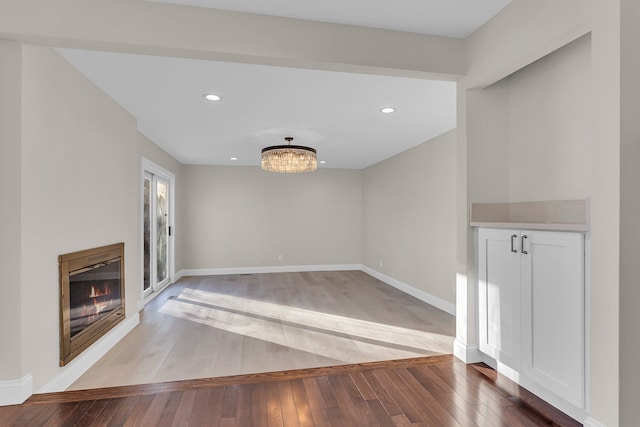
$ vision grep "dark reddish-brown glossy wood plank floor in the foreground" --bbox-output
[0,355,580,427]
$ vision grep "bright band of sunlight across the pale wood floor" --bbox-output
[160,289,453,363]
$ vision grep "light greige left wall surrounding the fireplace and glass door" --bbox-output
[0,42,188,390]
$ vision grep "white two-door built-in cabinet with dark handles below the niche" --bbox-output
[478,228,585,408]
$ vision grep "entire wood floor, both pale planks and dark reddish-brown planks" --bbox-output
[0,271,580,427]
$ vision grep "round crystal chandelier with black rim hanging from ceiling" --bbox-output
[262,136,318,173]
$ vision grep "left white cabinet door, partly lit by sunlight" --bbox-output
[478,228,521,370]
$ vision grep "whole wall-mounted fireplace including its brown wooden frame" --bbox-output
[58,243,124,366]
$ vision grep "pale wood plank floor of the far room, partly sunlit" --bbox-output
[69,271,455,390]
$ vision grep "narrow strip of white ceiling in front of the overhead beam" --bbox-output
[149,0,511,38]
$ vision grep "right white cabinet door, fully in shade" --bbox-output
[521,231,584,407]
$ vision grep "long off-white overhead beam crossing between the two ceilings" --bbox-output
[0,0,464,77]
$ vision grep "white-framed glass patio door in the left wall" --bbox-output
[142,157,175,300]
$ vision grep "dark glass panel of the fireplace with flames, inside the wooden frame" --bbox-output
[69,258,122,337]
